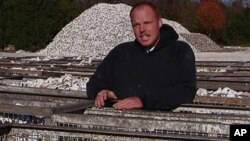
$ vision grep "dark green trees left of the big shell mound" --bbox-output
[0,0,81,51]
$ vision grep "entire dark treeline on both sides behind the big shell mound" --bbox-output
[0,0,250,51]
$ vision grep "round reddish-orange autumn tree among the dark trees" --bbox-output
[196,0,226,37]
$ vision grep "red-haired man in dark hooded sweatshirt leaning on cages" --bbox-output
[87,2,196,110]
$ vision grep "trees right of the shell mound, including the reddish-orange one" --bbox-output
[160,0,250,46]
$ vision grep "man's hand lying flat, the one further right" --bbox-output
[113,97,143,110]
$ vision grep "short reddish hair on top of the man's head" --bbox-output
[129,1,161,18]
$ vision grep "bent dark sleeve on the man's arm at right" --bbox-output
[138,42,196,110]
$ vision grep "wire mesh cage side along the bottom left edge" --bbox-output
[0,128,154,141]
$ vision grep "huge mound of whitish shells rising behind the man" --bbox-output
[37,3,196,59]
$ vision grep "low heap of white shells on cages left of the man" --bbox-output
[20,74,89,91]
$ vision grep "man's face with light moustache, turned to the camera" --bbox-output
[131,6,162,48]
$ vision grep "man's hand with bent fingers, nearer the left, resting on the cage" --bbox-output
[95,90,117,108]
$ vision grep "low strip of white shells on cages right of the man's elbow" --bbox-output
[196,87,250,98]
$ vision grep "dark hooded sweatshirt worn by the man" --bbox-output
[87,25,196,110]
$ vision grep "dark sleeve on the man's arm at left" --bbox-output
[87,50,114,100]
